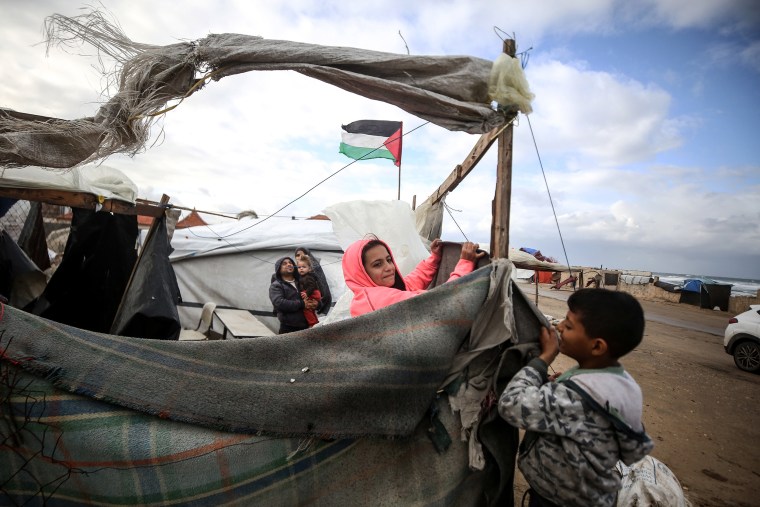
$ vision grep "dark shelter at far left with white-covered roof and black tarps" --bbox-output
[0,165,179,339]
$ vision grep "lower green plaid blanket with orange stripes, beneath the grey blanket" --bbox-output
[0,363,476,506]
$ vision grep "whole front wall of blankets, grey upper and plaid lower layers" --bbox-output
[0,263,540,505]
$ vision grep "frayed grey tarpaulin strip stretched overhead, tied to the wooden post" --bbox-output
[0,11,533,168]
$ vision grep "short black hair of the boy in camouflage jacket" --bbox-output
[567,289,644,359]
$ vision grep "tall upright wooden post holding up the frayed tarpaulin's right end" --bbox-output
[491,39,515,259]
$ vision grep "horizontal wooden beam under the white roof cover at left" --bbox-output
[0,187,165,218]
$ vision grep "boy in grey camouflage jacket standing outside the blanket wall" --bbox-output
[499,289,653,507]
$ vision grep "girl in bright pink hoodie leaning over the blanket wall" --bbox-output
[343,236,486,317]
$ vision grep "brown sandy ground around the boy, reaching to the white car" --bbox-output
[515,285,760,507]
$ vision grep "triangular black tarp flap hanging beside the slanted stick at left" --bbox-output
[111,216,182,340]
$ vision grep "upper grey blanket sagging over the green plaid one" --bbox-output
[0,261,537,437]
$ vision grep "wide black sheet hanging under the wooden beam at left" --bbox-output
[29,208,137,333]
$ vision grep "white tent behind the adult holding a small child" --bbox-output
[169,217,345,330]
